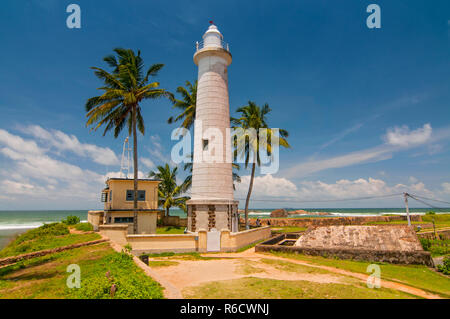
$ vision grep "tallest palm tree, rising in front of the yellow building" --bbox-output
[85,48,172,233]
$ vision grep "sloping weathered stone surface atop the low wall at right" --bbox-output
[295,225,423,251]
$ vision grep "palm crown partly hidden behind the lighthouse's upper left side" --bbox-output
[167,80,197,130]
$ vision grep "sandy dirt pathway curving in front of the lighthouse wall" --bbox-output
[138,248,441,299]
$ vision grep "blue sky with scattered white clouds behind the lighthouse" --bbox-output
[0,0,450,209]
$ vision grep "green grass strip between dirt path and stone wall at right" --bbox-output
[272,252,450,298]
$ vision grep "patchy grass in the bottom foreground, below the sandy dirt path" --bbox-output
[183,277,415,299]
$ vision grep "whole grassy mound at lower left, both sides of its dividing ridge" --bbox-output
[0,223,163,299]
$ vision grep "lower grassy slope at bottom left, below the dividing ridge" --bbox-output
[0,243,163,299]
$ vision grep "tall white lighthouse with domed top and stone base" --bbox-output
[187,22,238,232]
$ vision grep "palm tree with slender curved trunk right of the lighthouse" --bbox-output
[231,101,290,229]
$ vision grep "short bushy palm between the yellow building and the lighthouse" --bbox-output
[148,164,189,217]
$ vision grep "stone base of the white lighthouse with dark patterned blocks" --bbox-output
[186,199,239,232]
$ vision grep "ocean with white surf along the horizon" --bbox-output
[0,208,450,249]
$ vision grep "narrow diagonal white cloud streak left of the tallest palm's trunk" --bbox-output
[21,125,119,165]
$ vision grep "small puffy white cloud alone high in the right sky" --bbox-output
[384,123,433,147]
